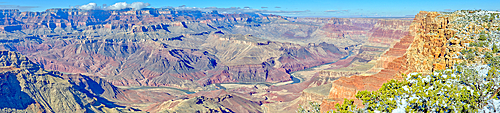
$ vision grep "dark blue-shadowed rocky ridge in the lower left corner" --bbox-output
[0,51,136,112]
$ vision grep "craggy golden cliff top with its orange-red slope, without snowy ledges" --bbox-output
[321,11,453,111]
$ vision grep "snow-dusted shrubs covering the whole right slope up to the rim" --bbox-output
[326,10,500,112]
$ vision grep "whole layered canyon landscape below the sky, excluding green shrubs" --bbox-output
[0,2,500,113]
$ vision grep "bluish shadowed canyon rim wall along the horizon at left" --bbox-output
[0,8,258,32]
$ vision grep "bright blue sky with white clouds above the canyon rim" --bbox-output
[0,0,500,17]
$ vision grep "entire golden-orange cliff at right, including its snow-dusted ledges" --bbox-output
[321,11,497,111]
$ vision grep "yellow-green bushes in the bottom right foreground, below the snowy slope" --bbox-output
[337,64,500,112]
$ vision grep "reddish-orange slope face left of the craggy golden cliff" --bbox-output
[321,13,425,112]
